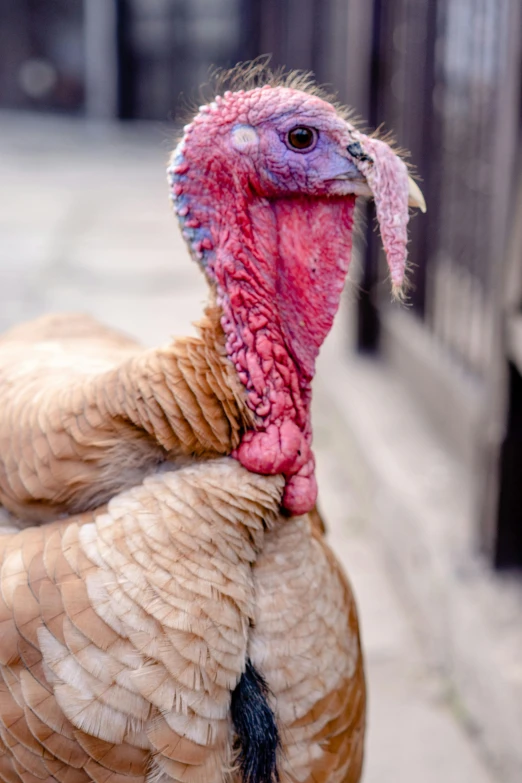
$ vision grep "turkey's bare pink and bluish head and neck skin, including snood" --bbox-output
[169,87,408,514]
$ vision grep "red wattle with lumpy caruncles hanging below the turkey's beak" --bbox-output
[219,197,354,514]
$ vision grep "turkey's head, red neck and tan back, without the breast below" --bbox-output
[0,67,424,522]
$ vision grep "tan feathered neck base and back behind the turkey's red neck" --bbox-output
[0,306,251,522]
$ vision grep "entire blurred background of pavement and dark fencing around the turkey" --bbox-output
[0,0,522,783]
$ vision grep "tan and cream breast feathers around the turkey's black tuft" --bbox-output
[0,459,365,783]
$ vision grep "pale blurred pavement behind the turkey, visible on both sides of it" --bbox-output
[0,114,502,783]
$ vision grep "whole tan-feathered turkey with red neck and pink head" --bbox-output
[0,66,423,783]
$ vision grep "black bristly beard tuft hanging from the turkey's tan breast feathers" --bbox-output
[232,660,281,783]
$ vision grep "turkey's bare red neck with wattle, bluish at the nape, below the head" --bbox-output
[171,156,355,514]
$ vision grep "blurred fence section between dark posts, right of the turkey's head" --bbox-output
[362,0,515,375]
